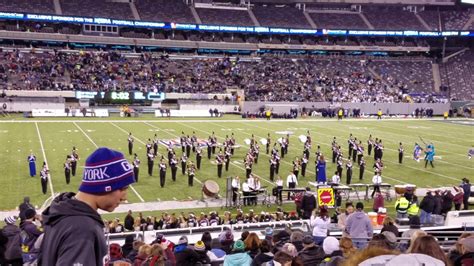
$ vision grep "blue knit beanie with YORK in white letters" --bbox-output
[79,148,135,194]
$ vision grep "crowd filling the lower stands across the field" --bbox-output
[0,51,458,103]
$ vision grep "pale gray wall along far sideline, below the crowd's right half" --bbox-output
[242,102,450,115]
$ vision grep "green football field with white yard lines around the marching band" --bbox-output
[0,116,474,210]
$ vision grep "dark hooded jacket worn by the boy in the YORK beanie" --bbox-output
[41,192,107,265]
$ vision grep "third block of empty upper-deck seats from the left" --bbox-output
[135,0,196,23]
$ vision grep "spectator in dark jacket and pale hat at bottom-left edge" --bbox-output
[0,216,23,265]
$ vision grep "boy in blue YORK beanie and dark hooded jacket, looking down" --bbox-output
[41,148,135,265]
